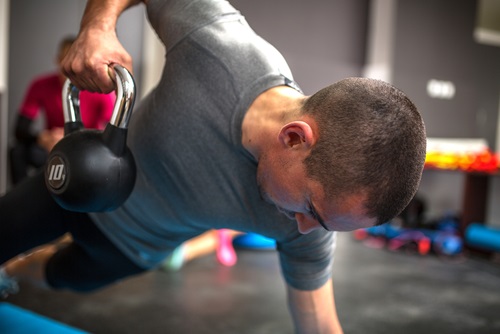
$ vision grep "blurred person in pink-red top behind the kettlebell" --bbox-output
[10,37,115,184]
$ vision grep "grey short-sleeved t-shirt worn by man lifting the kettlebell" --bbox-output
[92,0,335,290]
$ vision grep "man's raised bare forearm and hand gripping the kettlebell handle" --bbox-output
[62,0,141,93]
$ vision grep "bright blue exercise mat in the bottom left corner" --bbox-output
[0,302,87,334]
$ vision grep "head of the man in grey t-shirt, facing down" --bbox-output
[257,78,426,233]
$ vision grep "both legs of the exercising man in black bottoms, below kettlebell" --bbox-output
[0,173,144,291]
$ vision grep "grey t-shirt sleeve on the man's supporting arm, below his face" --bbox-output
[277,230,337,290]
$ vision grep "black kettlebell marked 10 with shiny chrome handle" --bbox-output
[45,64,136,212]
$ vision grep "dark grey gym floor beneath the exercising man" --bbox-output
[0,233,500,334]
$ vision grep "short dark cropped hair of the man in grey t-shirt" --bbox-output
[302,78,426,225]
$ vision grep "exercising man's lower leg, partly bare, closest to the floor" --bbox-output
[0,230,144,295]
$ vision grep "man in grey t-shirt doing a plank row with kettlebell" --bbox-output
[0,0,425,333]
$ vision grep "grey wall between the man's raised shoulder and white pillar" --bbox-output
[230,0,369,94]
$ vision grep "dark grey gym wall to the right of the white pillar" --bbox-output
[393,0,500,225]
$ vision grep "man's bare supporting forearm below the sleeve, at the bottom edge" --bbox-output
[287,279,343,334]
